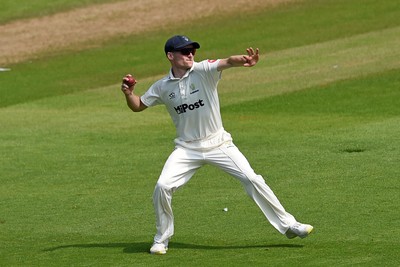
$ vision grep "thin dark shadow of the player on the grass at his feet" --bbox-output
[43,242,303,253]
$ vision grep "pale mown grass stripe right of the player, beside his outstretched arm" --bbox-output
[220,27,400,104]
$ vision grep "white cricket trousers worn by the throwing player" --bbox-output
[153,143,296,243]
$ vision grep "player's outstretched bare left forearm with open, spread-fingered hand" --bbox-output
[217,47,259,71]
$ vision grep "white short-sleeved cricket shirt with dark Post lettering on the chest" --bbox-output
[141,60,232,149]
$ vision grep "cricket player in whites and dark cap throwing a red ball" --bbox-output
[121,35,313,254]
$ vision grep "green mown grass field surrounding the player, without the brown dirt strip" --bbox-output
[0,0,400,266]
